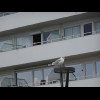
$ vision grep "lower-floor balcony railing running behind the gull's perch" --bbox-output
[0,74,100,87]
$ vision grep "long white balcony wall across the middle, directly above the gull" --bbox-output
[0,34,100,68]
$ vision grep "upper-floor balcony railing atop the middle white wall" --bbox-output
[0,30,100,52]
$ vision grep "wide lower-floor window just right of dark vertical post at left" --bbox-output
[17,71,32,86]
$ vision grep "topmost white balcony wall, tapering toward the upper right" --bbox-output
[0,12,84,32]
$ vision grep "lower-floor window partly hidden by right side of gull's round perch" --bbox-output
[65,64,82,80]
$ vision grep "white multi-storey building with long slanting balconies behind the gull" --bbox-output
[0,12,100,87]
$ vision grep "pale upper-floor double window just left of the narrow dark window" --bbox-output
[64,25,81,39]
